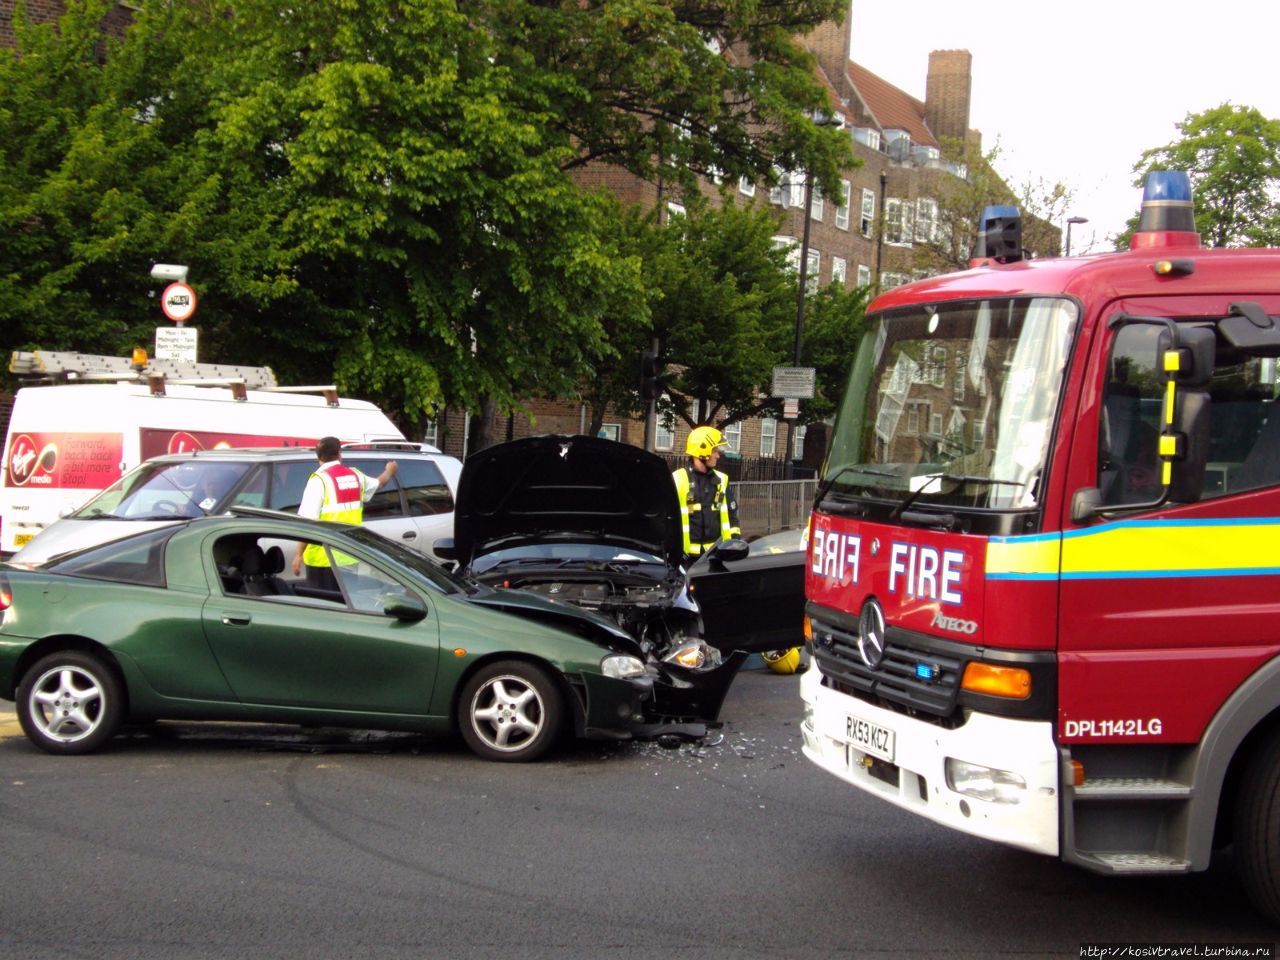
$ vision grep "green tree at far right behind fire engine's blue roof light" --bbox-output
[1116,104,1280,250]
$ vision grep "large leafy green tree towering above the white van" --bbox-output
[0,0,849,448]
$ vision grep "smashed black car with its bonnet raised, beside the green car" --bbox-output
[435,435,803,732]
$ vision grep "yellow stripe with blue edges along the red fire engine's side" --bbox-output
[986,517,1280,580]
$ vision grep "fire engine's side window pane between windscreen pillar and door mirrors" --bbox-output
[1098,324,1165,506]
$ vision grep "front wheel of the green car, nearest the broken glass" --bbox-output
[458,660,564,763]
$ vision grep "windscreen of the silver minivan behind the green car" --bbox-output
[72,460,252,520]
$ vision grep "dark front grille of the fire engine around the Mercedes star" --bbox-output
[810,618,964,719]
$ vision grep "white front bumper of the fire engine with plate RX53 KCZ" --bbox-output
[800,663,1061,856]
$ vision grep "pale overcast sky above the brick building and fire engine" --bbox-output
[849,0,1280,253]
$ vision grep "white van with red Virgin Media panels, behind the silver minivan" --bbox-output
[0,383,404,556]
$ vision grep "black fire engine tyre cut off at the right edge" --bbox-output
[1234,731,1280,923]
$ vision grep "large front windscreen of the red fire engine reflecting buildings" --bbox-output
[823,297,1076,511]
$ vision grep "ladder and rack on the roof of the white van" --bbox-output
[9,349,280,390]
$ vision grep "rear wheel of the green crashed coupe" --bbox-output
[17,650,124,755]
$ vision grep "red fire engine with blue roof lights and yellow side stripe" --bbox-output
[801,172,1280,920]
